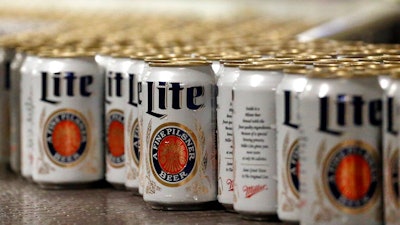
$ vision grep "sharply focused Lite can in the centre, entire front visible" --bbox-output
[142,61,217,210]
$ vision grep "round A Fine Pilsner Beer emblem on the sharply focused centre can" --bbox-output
[149,123,199,187]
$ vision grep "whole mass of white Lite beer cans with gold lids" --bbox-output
[0,11,400,224]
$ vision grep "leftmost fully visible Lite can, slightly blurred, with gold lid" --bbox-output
[31,50,104,188]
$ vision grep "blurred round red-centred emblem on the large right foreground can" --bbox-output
[323,140,379,213]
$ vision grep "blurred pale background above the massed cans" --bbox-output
[0,0,400,43]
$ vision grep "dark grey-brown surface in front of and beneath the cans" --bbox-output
[0,173,285,225]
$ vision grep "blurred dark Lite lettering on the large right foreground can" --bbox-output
[318,94,382,136]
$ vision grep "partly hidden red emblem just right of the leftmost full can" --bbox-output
[106,110,125,167]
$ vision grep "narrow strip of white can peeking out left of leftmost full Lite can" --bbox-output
[19,51,41,180]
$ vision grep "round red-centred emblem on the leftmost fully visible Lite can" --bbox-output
[43,109,89,167]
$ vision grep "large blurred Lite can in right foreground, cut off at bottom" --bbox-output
[299,70,383,225]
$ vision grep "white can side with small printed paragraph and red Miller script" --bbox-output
[233,90,277,213]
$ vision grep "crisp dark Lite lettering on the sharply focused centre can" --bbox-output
[146,81,205,118]
